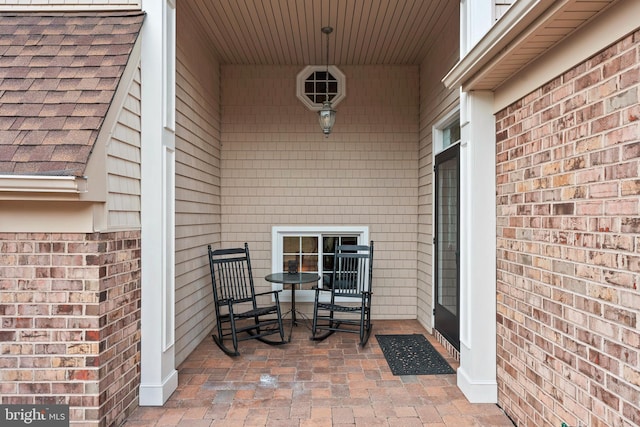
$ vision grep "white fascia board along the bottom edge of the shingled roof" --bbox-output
[0,175,87,194]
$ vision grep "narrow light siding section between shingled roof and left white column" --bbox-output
[107,66,141,230]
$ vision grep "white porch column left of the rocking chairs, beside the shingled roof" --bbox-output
[140,0,178,406]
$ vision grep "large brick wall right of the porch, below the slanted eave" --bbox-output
[497,32,640,427]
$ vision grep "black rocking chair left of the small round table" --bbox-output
[208,243,287,356]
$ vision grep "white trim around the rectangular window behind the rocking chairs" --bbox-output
[271,225,369,304]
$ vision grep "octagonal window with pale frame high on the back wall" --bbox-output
[296,65,346,111]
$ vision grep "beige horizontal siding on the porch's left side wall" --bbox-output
[175,8,220,364]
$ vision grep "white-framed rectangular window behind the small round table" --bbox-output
[271,225,369,302]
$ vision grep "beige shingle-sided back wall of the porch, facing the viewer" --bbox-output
[221,66,418,319]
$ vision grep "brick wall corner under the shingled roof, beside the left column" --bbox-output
[0,231,140,426]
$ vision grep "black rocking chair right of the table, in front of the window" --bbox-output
[311,241,373,346]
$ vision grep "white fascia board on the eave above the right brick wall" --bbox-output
[442,0,567,89]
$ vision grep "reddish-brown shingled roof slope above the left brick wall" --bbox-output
[0,11,144,176]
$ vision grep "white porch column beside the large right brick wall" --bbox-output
[457,0,498,403]
